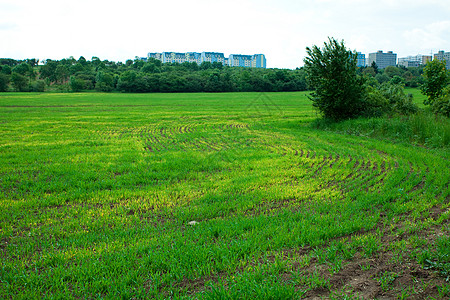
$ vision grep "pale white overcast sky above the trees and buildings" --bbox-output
[0,0,450,69]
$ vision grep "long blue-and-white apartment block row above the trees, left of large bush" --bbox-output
[148,52,266,68]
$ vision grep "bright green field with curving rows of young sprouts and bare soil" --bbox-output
[0,92,450,299]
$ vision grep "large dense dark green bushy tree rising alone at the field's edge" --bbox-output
[304,38,365,120]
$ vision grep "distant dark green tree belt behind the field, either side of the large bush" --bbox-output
[0,57,423,93]
